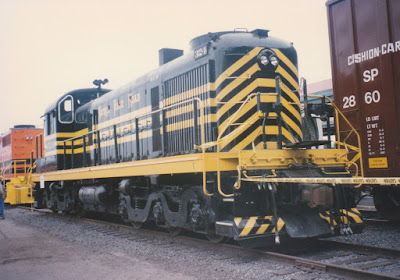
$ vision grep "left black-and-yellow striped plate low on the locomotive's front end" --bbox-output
[234,216,285,237]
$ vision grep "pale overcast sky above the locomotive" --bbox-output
[0,0,331,133]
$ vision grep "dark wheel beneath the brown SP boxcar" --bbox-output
[372,187,400,220]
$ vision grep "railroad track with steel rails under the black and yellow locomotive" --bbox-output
[20,207,400,279]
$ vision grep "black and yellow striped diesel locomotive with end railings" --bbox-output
[33,29,362,246]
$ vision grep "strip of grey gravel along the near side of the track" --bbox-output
[6,208,346,280]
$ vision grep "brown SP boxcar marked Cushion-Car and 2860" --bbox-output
[326,0,400,216]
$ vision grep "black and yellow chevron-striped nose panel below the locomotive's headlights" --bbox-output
[215,48,302,151]
